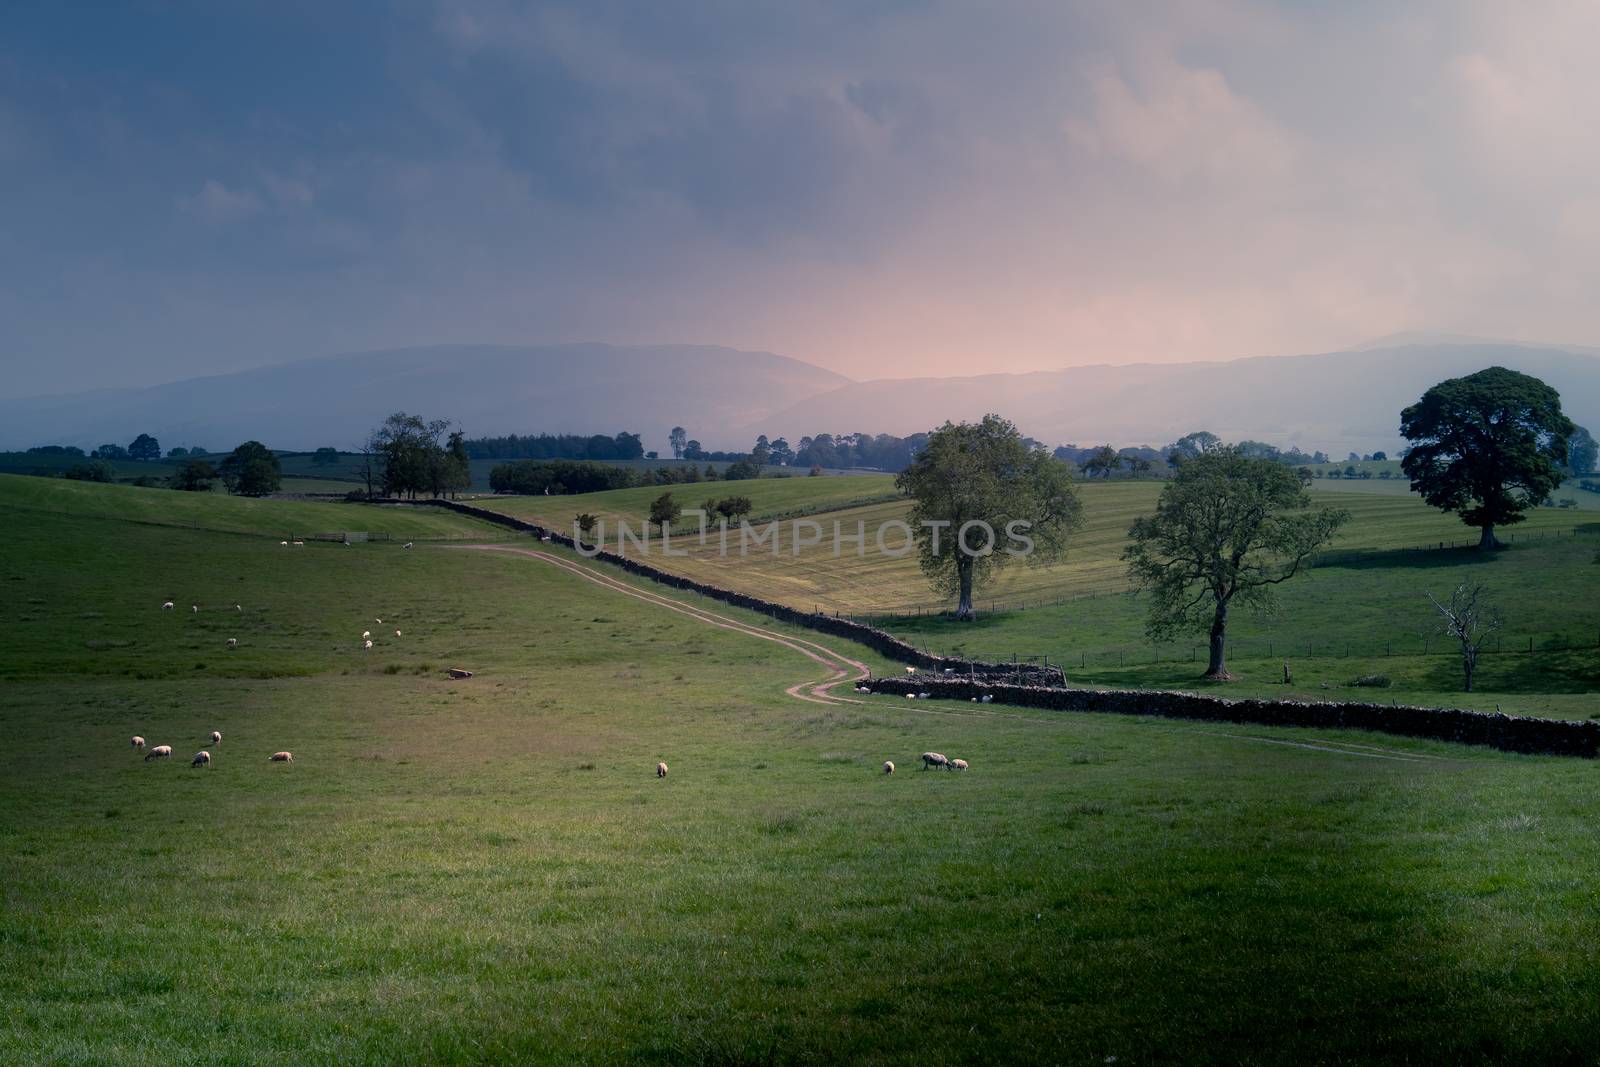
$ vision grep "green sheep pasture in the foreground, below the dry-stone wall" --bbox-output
[0,480,1600,1064]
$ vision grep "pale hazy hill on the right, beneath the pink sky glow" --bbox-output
[746,341,1600,456]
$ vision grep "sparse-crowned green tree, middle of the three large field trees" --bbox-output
[1122,448,1350,680]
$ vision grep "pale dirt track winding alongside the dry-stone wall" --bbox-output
[442,544,1466,765]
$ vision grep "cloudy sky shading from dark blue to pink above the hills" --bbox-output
[0,0,1600,397]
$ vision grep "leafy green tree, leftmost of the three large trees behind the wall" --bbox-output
[894,414,1082,619]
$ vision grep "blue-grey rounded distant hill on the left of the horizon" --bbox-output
[0,344,850,451]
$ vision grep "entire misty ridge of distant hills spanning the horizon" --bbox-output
[0,334,1600,456]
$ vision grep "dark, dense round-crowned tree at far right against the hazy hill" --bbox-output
[1400,366,1576,549]
